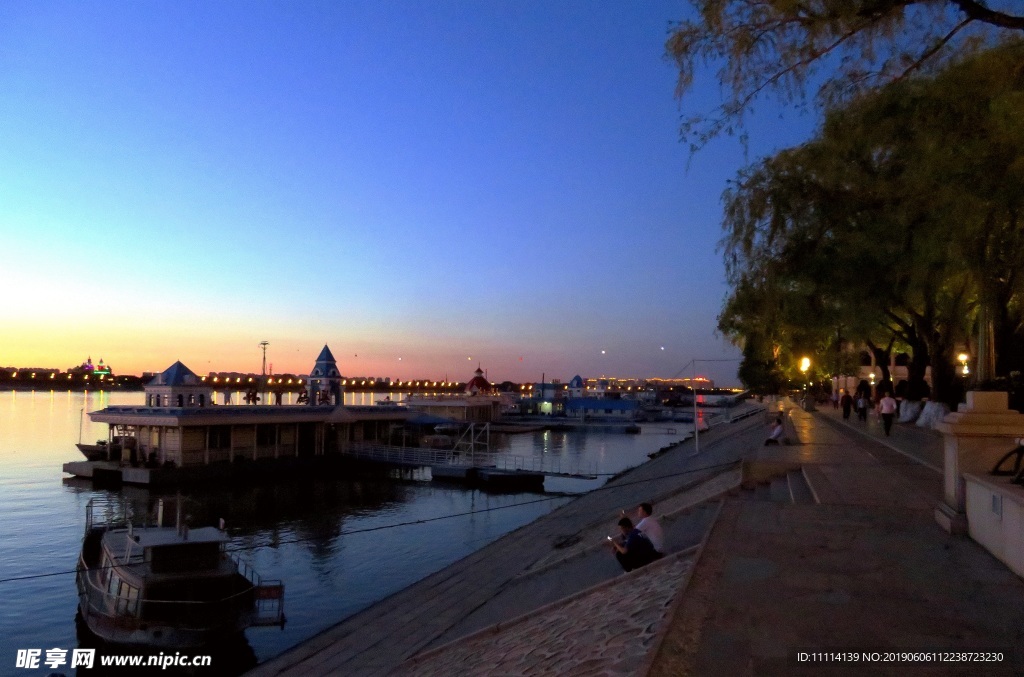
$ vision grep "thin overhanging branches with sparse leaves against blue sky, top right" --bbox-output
[666,0,1024,150]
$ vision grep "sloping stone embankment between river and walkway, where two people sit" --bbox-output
[245,403,765,675]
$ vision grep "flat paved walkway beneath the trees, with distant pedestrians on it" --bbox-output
[650,403,1024,677]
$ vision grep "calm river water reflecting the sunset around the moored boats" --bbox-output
[0,391,688,675]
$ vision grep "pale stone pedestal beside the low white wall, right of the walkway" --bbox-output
[935,390,1024,534]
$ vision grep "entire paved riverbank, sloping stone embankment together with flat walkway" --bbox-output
[245,406,1024,677]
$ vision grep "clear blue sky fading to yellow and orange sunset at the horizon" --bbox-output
[0,0,814,385]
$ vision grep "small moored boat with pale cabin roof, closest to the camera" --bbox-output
[77,499,285,648]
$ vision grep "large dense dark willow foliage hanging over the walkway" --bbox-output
[719,41,1024,396]
